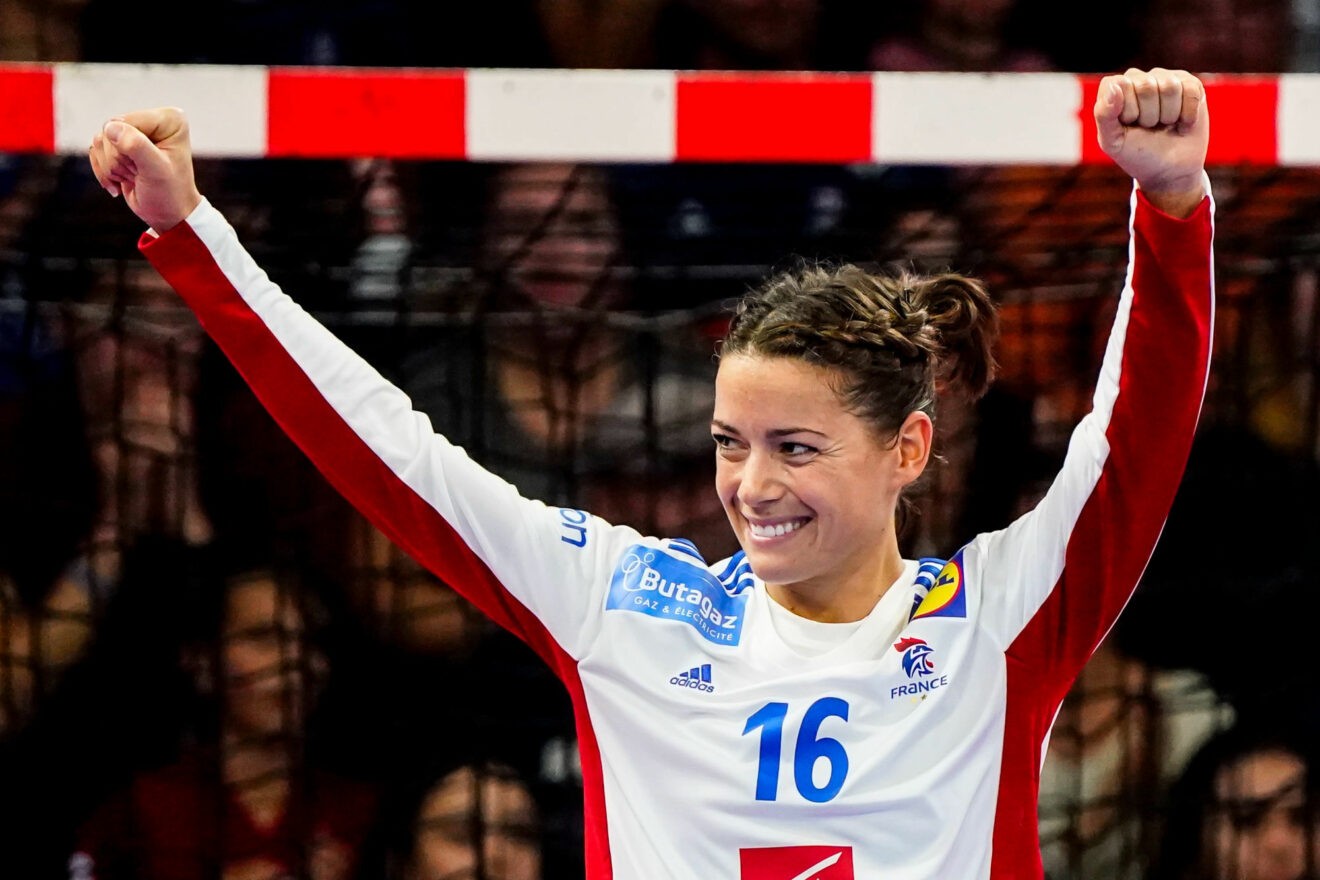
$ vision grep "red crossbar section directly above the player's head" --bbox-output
[676,74,871,162]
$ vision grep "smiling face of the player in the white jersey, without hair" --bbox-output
[711,355,931,619]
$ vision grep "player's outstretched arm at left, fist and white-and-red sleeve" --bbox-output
[92,111,636,666]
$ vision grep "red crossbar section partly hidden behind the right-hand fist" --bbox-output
[1077,75,1279,165]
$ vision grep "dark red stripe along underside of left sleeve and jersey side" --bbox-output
[139,223,612,880]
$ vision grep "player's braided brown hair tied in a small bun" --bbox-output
[719,264,998,438]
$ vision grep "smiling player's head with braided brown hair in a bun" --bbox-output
[713,265,997,623]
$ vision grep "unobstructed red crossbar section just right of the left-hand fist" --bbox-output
[267,67,467,158]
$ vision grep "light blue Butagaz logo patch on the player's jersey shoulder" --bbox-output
[605,545,747,645]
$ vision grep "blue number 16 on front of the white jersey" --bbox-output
[743,697,847,803]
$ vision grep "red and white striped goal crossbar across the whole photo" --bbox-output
[0,63,1320,166]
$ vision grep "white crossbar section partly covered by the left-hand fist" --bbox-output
[54,63,267,157]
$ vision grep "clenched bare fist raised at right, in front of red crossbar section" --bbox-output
[1096,67,1210,216]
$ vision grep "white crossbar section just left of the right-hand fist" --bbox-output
[871,73,1081,165]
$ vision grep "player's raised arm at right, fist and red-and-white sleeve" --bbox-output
[965,69,1214,686]
